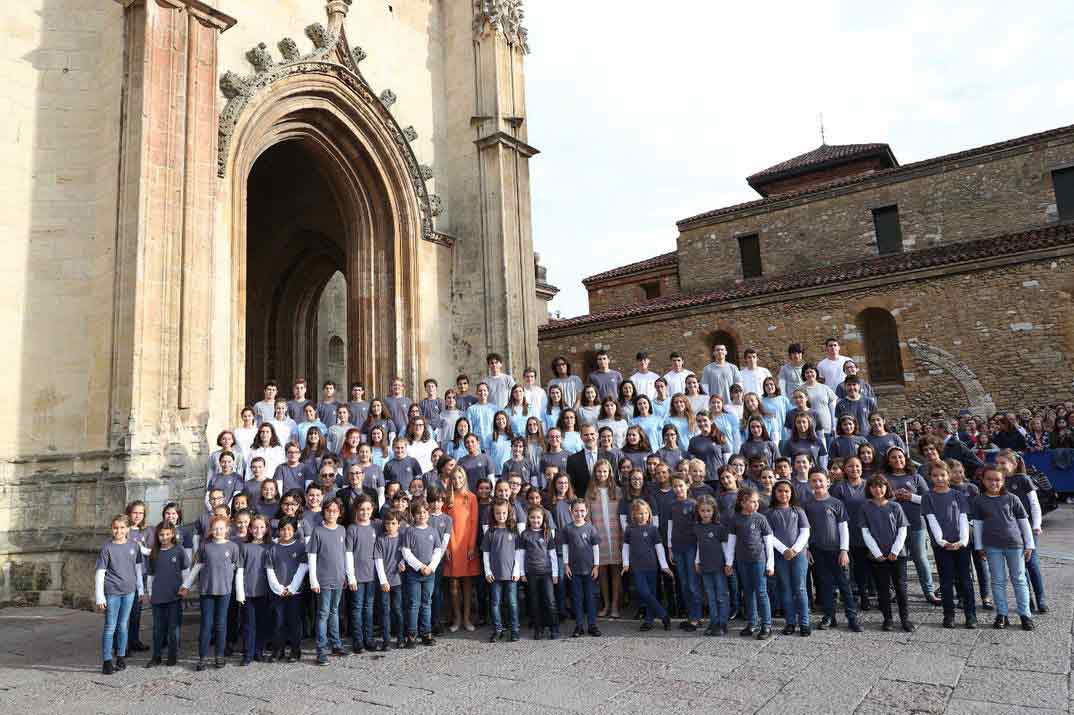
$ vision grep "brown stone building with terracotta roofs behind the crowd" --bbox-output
[539,126,1074,415]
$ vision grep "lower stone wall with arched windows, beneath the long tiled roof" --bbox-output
[540,257,1074,417]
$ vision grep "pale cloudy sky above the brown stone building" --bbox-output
[525,0,1074,318]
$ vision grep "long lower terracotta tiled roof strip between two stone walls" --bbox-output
[538,223,1074,333]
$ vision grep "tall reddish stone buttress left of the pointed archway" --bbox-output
[110,0,234,504]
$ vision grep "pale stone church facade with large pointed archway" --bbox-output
[0,0,545,602]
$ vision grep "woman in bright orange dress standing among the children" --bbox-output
[444,467,481,632]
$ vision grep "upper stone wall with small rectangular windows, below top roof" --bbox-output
[679,132,1074,292]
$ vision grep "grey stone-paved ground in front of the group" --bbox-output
[0,507,1074,715]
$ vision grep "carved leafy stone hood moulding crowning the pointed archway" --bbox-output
[217,0,440,245]
